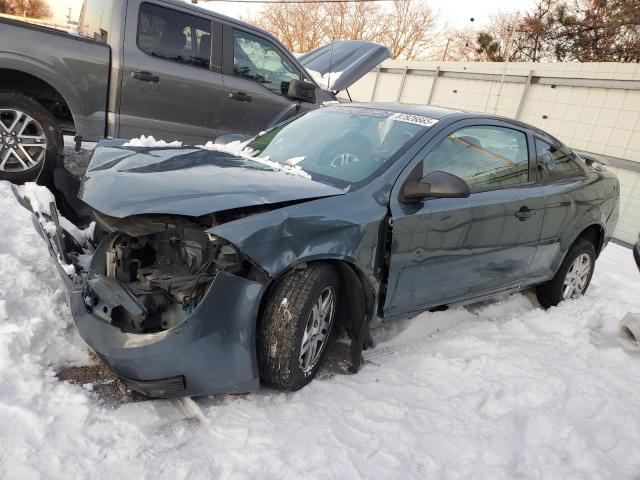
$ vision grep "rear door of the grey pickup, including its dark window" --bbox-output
[117,0,224,144]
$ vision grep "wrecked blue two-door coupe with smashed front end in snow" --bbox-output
[16,104,619,397]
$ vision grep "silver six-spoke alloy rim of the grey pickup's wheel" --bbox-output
[0,109,47,172]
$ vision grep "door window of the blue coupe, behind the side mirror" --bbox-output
[423,126,529,192]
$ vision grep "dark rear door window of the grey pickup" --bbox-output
[138,3,211,68]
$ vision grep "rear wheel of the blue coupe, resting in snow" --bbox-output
[536,239,596,308]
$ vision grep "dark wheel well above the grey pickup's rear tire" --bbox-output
[0,68,75,133]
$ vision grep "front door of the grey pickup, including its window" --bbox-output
[220,25,312,135]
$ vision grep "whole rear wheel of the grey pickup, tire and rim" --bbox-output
[0,92,64,183]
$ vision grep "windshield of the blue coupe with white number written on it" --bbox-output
[247,106,435,188]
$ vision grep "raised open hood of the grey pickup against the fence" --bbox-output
[298,40,391,92]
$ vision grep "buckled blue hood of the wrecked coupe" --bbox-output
[78,140,344,218]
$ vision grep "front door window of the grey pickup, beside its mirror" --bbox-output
[233,30,303,94]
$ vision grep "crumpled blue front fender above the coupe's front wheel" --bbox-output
[209,189,388,292]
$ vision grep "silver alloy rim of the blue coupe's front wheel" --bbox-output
[298,287,336,374]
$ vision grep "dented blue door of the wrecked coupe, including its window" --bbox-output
[385,120,545,317]
